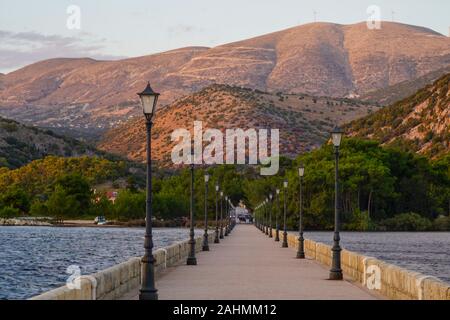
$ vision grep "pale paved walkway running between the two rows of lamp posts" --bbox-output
[124,225,377,300]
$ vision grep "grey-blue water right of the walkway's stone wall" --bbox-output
[290,232,450,283]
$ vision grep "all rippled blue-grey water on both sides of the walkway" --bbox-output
[0,227,450,299]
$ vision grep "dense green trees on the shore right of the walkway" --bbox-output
[247,139,450,230]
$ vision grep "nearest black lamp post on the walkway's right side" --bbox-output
[330,126,344,280]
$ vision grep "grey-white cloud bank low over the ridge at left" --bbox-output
[0,30,124,72]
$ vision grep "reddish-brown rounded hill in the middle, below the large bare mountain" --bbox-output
[98,85,377,166]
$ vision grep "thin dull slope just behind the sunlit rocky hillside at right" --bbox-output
[359,66,450,106]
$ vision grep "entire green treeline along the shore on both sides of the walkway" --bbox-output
[0,139,450,230]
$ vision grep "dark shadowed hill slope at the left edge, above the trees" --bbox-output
[0,117,97,168]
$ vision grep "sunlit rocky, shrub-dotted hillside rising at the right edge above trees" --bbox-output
[347,73,450,158]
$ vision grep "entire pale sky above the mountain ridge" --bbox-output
[0,0,450,73]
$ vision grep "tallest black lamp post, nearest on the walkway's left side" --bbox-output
[138,83,159,300]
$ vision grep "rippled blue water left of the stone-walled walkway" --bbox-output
[0,227,201,299]
